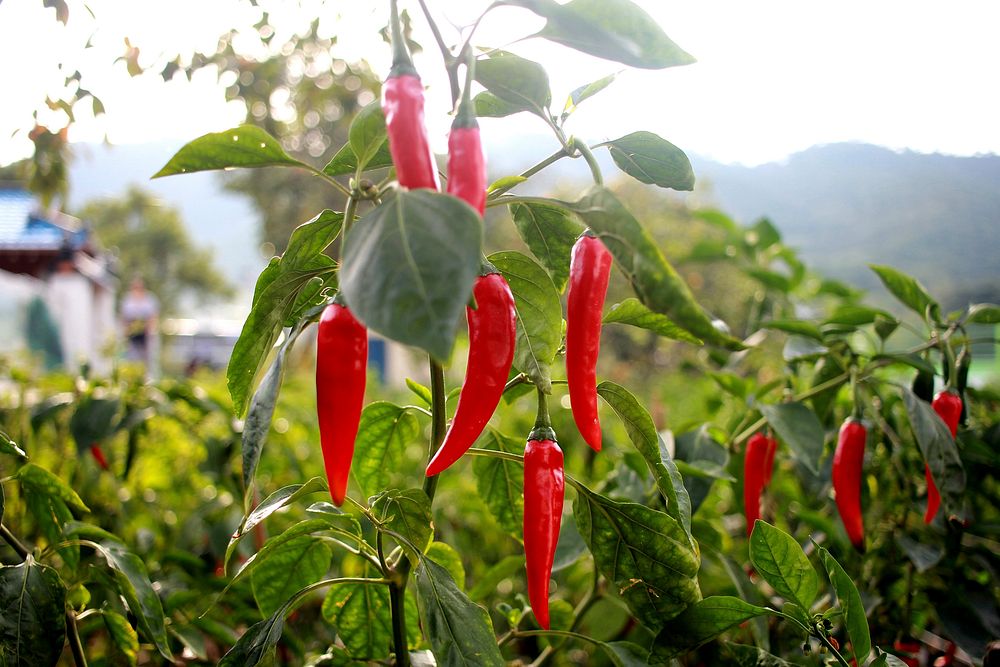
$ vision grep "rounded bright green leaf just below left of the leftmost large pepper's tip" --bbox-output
[250,535,333,616]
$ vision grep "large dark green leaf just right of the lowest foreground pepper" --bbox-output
[573,487,701,630]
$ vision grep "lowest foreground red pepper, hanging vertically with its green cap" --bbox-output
[524,428,566,630]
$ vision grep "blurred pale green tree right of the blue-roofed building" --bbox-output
[78,187,232,314]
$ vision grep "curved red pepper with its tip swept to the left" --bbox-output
[427,270,517,476]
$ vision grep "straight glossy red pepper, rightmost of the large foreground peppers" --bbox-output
[566,232,611,452]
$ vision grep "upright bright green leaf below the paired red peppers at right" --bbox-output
[750,519,819,612]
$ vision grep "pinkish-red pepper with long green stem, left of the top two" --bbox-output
[382,0,438,190]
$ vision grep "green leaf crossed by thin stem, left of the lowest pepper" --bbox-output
[472,428,524,541]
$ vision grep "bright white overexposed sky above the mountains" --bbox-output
[0,0,1000,165]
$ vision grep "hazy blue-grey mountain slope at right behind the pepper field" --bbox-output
[692,144,1000,307]
